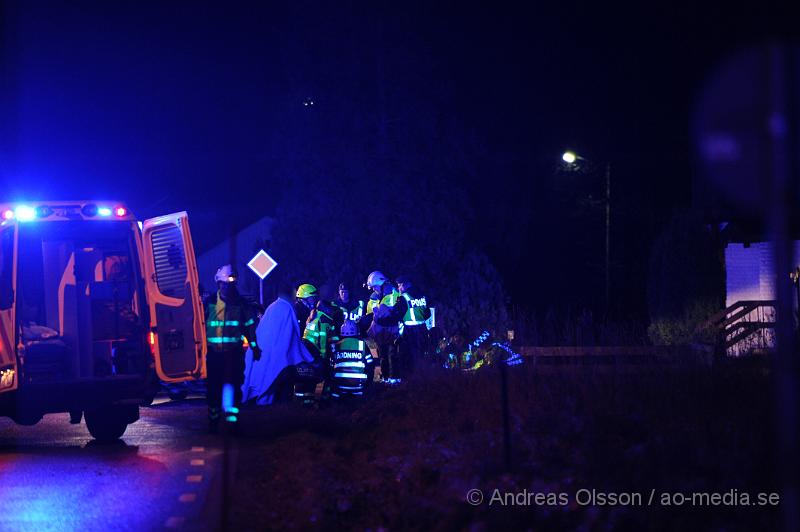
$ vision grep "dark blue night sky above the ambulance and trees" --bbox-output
[0,2,796,314]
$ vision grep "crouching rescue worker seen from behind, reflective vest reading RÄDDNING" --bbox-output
[330,320,375,399]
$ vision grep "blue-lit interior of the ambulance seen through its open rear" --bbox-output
[17,221,147,383]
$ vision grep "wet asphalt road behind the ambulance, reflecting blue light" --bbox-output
[0,398,223,531]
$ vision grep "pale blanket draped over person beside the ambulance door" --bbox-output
[242,298,314,405]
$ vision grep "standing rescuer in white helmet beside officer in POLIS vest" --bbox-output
[366,271,407,384]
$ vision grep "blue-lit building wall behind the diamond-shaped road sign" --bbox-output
[197,216,273,297]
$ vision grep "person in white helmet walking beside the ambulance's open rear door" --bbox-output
[204,264,261,432]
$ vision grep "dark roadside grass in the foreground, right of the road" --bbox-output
[231,364,777,530]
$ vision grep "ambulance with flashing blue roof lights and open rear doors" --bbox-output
[0,201,206,441]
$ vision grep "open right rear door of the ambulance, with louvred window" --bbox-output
[142,212,206,382]
